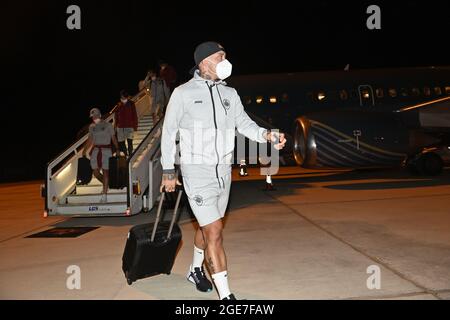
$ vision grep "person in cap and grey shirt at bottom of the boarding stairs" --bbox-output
[83,108,119,203]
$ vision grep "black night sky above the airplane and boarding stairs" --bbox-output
[0,0,450,182]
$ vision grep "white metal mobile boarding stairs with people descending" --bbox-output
[42,90,162,216]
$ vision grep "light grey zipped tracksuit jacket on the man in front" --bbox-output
[161,70,267,178]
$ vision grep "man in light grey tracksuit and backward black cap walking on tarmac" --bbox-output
[161,42,286,300]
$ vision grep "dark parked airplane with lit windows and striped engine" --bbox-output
[227,66,450,175]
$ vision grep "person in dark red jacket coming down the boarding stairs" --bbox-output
[115,90,138,157]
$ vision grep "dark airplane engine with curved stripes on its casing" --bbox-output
[293,111,437,168]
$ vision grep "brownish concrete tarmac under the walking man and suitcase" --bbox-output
[0,167,450,300]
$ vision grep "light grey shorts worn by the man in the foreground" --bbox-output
[183,173,231,227]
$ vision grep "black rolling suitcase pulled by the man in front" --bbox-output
[122,189,183,285]
